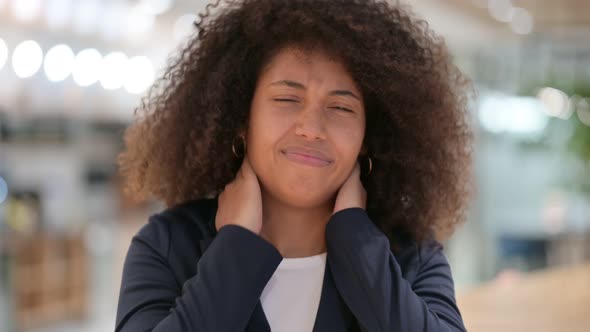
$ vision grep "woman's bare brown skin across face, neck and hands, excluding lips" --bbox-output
[216,49,367,258]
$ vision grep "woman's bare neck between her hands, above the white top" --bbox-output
[260,191,332,258]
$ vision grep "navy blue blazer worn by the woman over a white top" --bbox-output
[115,199,465,332]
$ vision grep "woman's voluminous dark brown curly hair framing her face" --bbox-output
[119,0,472,244]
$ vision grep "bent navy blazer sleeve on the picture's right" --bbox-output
[326,208,465,332]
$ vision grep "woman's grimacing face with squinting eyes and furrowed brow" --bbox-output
[247,48,365,207]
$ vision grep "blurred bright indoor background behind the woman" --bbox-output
[0,0,590,332]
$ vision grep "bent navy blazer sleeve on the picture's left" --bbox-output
[115,220,282,332]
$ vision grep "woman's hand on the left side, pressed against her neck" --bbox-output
[215,156,262,234]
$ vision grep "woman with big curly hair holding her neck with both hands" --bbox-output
[116,0,470,331]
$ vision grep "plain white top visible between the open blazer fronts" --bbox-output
[260,252,326,332]
